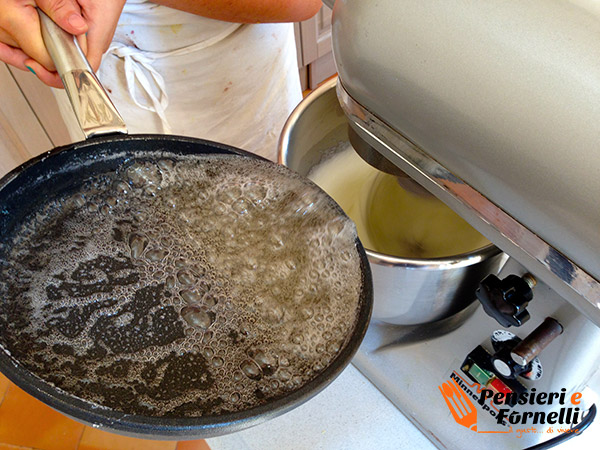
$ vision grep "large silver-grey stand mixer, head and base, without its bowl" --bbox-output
[326,0,600,448]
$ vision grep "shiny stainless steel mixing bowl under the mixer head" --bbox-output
[279,79,507,325]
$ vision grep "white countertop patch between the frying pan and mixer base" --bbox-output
[207,365,435,450]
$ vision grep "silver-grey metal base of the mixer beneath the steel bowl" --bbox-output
[353,260,600,449]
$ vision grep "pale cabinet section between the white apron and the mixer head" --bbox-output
[295,5,336,90]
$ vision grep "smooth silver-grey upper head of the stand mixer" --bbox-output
[333,0,600,324]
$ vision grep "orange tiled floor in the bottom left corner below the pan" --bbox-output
[0,374,210,450]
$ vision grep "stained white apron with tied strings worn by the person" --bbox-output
[54,0,302,160]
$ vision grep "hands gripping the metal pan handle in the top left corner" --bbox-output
[0,0,125,87]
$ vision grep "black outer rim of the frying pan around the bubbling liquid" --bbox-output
[0,134,373,439]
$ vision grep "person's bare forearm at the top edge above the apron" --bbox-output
[151,0,321,23]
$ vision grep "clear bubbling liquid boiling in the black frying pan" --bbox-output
[0,156,362,416]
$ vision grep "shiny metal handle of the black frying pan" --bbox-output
[38,9,127,138]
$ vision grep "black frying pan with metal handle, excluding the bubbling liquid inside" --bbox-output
[0,16,373,439]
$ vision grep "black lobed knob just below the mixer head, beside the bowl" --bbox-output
[475,274,535,328]
